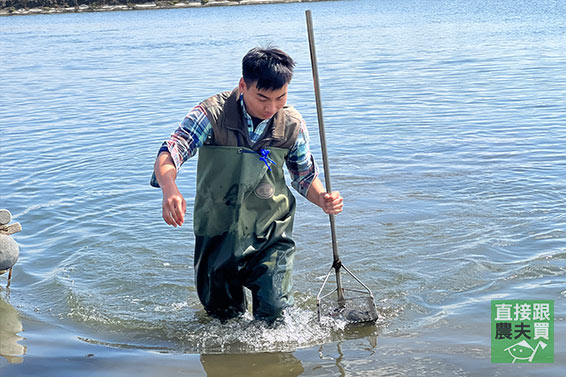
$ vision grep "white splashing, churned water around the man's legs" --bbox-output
[67,296,386,354]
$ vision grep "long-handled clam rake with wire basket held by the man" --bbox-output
[306,10,377,324]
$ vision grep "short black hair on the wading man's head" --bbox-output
[242,47,295,90]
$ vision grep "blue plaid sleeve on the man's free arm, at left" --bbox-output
[150,105,212,187]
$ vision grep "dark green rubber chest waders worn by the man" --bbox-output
[194,146,295,322]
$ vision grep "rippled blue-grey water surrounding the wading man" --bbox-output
[0,0,566,376]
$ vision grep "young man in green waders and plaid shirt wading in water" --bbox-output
[151,48,343,323]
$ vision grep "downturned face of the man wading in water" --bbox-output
[239,78,289,119]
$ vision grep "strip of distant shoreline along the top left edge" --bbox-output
[0,0,336,16]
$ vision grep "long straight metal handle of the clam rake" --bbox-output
[306,10,344,302]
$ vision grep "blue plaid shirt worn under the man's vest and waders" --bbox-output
[159,96,318,197]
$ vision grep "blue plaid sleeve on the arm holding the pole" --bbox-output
[286,119,318,198]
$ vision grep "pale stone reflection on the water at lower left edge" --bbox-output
[0,297,26,364]
